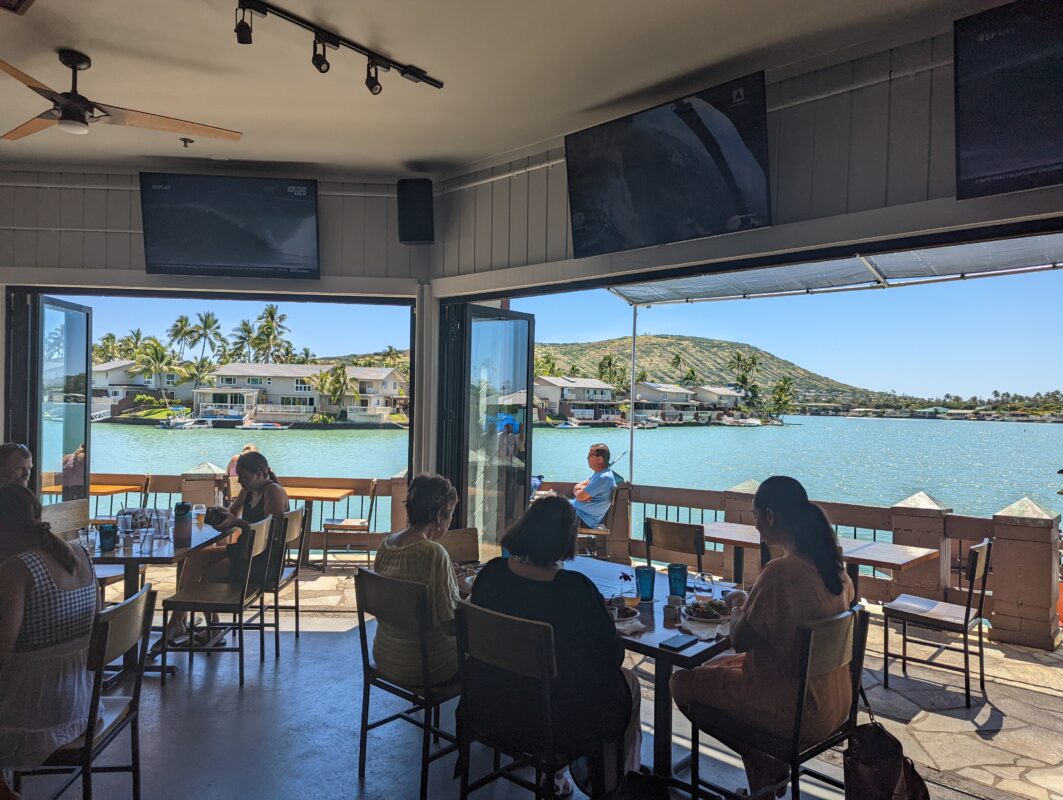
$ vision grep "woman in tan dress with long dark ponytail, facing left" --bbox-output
[672,476,853,794]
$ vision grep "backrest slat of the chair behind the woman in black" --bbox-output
[457,601,557,681]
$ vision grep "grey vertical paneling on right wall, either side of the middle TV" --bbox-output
[432,34,955,277]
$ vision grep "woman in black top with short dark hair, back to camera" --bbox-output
[466,497,642,795]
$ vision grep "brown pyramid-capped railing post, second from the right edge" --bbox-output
[890,492,952,600]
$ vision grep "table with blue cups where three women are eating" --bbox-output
[566,556,730,779]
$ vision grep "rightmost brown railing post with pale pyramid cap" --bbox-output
[989,497,1061,650]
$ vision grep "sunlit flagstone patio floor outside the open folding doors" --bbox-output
[109,557,1063,800]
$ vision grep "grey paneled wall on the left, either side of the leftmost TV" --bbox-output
[0,171,429,283]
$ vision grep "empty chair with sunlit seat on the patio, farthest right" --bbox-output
[882,539,993,709]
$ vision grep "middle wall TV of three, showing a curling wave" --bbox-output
[564,72,772,258]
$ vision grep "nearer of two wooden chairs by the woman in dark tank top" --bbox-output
[161,516,273,686]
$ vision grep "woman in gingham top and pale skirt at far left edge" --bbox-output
[0,484,99,800]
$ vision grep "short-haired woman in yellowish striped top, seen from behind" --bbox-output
[373,475,458,686]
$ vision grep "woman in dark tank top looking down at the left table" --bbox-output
[159,450,288,651]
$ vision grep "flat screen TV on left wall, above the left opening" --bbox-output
[140,172,320,278]
